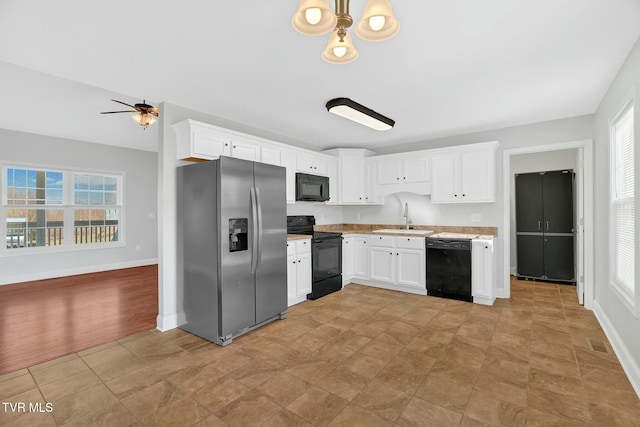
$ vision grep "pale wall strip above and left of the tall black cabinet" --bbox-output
[509,149,578,274]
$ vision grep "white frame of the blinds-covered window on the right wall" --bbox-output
[609,91,640,318]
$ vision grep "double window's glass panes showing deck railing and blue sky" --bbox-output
[2,166,123,252]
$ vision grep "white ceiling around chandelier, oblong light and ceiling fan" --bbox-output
[0,0,640,150]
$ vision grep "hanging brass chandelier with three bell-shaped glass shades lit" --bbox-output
[292,0,400,64]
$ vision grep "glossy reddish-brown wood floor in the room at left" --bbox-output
[0,265,158,374]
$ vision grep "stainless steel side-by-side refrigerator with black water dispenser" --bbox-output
[177,156,287,345]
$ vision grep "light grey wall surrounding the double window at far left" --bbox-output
[0,129,158,284]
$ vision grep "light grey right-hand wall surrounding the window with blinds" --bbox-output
[594,39,640,396]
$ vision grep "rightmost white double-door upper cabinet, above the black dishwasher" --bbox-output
[431,142,498,203]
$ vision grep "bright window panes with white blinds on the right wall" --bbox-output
[611,103,636,307]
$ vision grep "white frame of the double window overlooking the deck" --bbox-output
[0,161,126,256]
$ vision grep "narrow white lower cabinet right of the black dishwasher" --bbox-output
[471,239,496,305]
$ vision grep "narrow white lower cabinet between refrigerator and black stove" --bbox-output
[287,239,311,306]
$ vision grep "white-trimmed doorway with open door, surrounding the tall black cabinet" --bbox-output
[502,140,594,309]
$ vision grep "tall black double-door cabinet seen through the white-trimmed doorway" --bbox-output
[515,170,575,282]
